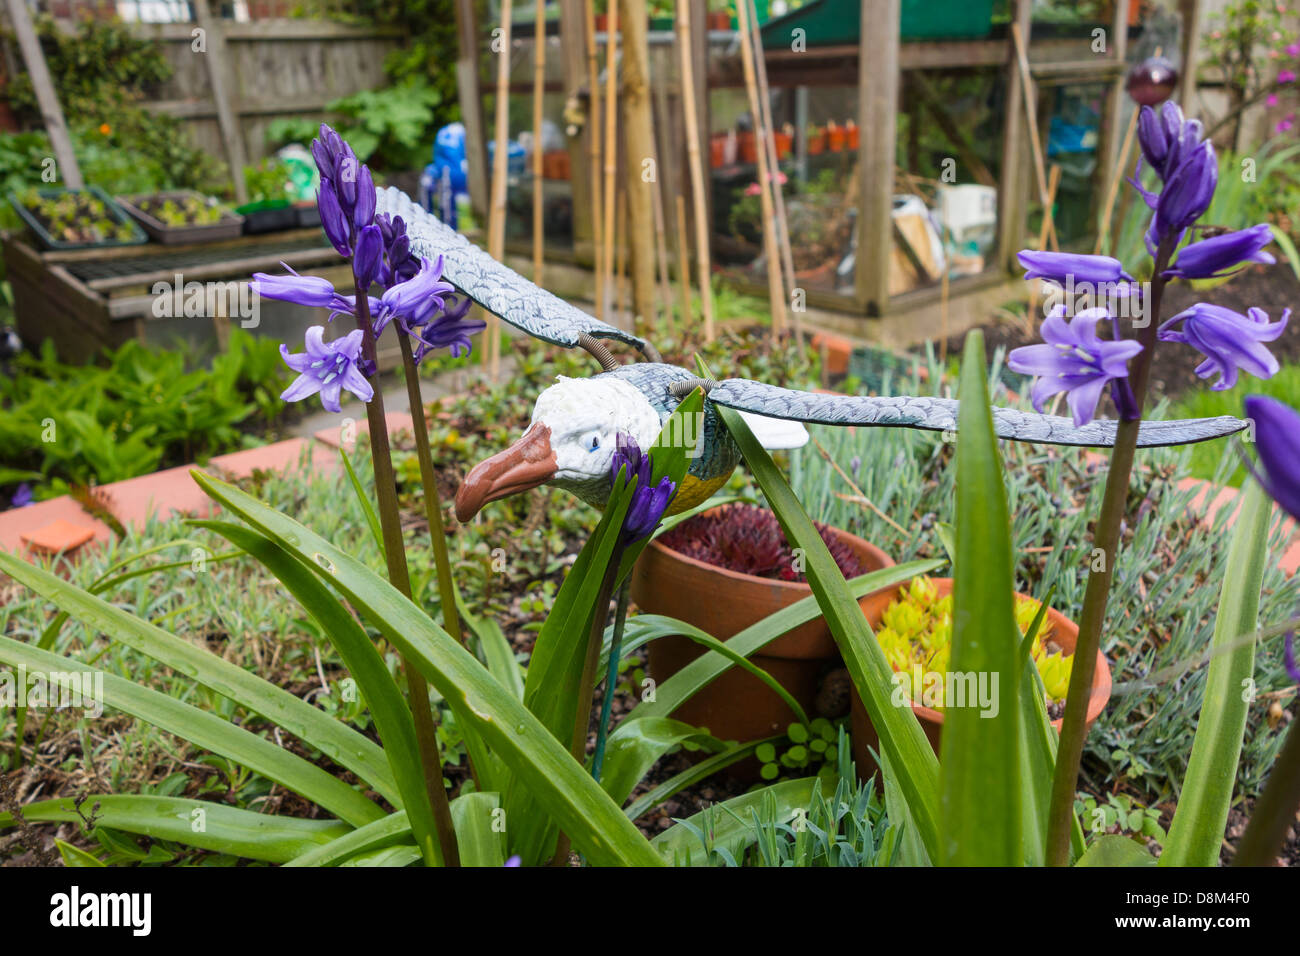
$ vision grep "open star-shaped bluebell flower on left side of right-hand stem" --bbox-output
[1006,306,1141,427]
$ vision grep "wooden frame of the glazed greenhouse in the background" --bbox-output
[456,0,1203,342]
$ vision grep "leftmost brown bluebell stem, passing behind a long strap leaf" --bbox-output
[356,280,460,866]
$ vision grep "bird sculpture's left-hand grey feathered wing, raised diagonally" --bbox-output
[374,186,646,351]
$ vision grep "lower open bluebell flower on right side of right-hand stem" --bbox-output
[1158,302,1291,392]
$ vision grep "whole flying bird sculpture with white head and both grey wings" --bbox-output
[377,187,1247,520]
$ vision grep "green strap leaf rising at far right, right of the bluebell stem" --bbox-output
[1160,481,1273,866]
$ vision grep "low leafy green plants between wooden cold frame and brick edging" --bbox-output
[0,330,287,494]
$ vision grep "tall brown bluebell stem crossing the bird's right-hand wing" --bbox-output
[1045,237,1178,866]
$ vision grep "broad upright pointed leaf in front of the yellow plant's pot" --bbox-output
[939,329,1024,866]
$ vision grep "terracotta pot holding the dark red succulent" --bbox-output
[632,509,893,754]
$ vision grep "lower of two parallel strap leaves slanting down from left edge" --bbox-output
[0,637,384,826]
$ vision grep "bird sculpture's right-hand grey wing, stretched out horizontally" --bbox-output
[709,378,1247,447]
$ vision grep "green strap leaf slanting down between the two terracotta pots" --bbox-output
[716,406,939,857]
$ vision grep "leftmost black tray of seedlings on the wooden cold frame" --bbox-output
[9,186,150,250]
